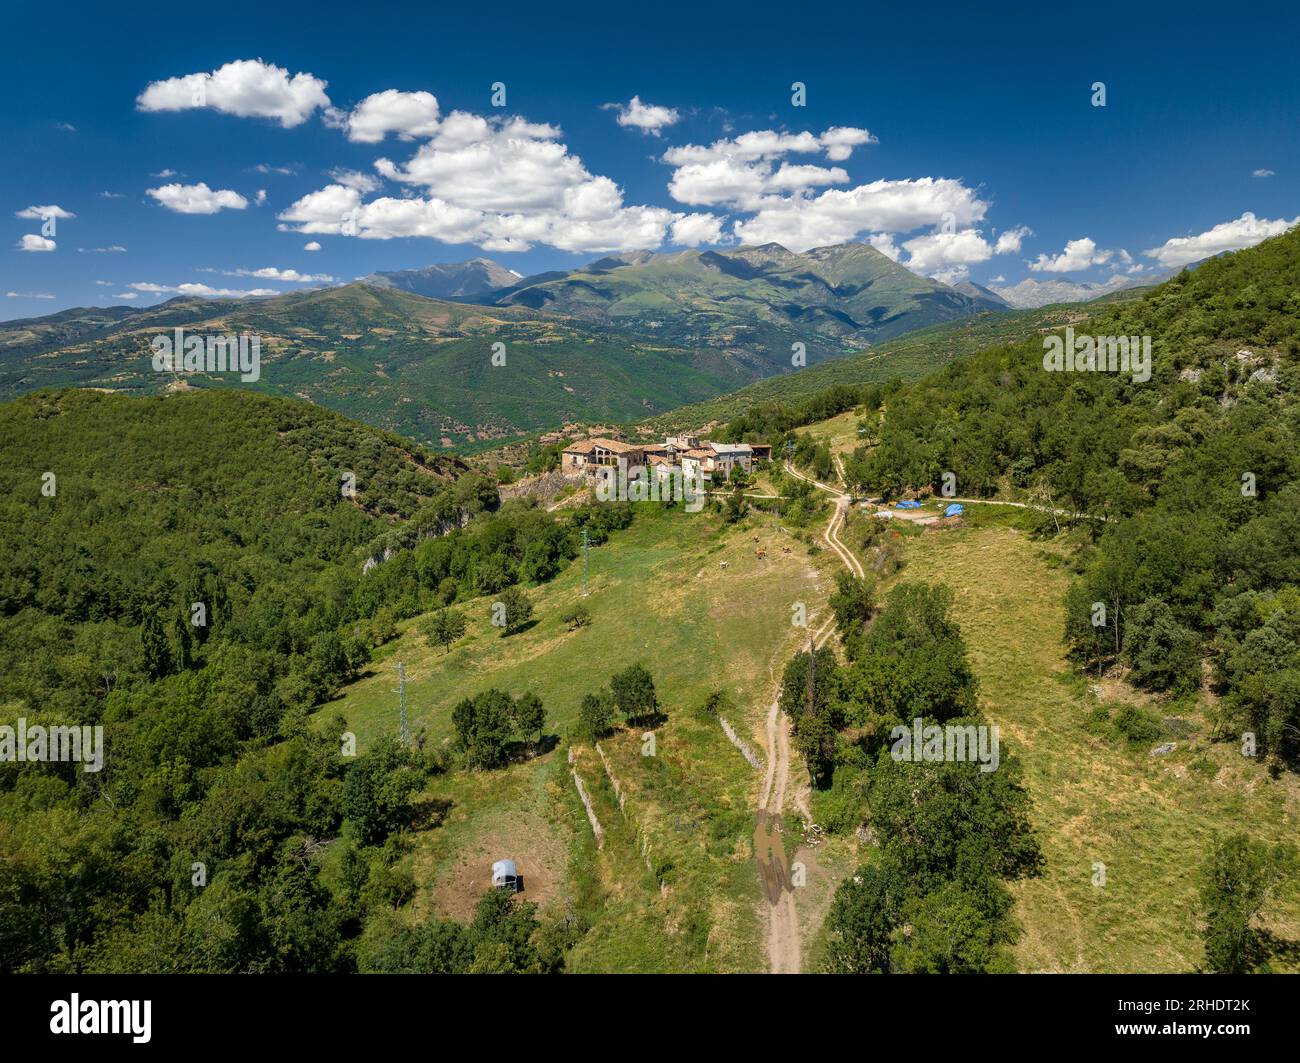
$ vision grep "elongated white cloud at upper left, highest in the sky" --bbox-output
[135,58,329,129]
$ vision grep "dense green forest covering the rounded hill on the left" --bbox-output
[0,391,603,972]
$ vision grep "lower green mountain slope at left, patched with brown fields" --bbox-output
[0,283,758,450]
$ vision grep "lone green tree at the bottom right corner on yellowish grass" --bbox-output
[1200,834,1296,975]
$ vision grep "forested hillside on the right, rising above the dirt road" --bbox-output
[846,231,1300,767]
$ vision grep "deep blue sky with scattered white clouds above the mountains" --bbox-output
[0,1,1300,318]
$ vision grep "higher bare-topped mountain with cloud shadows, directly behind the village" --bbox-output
[495,243,997,363]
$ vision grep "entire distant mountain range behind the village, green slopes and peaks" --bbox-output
[0,243,1045,451]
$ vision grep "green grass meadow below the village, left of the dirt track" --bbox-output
[319,506,828,971]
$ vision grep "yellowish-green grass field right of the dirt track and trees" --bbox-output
[897,519,1300,972]
